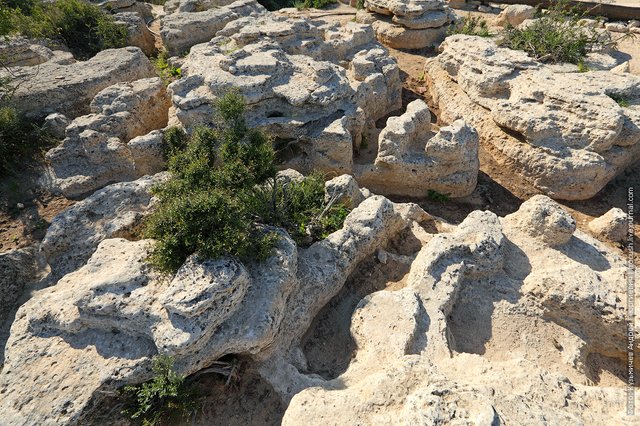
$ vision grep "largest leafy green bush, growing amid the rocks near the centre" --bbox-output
[145,93,346,272]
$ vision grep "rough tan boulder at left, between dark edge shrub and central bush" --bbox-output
[47,77,170,197]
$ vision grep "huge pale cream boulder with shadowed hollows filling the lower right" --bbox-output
[284,199,638,425]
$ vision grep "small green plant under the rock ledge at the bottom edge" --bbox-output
[123,355,199,426]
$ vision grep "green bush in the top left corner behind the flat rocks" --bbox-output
[0,0,127,58]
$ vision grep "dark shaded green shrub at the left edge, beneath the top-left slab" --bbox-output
[0,106,55,176]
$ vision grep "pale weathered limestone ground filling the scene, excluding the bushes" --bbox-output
[0,0,640,425]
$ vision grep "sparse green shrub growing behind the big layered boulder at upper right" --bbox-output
[500,0,614,64]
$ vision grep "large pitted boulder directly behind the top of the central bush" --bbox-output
[169,14,401,173]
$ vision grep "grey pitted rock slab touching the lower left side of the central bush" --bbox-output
[40,173,168,278]
